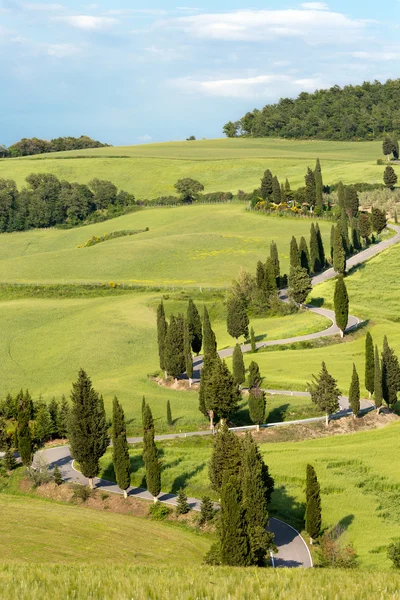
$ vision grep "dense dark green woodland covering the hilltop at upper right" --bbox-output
[224,79,400,140]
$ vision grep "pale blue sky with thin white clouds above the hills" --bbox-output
[0,0,400,145]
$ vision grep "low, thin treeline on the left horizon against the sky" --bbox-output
[0,135,109,158]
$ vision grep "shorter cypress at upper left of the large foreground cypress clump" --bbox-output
[208,420,240,494]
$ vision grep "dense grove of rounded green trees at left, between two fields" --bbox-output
[0,173,139,233]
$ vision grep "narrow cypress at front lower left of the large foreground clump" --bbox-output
[219,477,251,567]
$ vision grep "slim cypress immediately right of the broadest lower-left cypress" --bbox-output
[112,397,131,498]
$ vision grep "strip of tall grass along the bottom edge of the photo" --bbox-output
[0,564,400,600]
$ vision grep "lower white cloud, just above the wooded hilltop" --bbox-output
[171,74,329,98]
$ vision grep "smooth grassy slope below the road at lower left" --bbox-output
[0,494,210,564]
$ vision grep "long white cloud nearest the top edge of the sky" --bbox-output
[171,3,367,43]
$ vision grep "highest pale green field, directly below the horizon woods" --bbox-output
[0,138,384,199]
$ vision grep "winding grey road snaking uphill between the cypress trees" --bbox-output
[5,225,400,568]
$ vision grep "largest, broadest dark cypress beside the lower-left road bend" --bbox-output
[68,369,110,489]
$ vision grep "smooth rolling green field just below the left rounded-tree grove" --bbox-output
[0,204,330,287]
